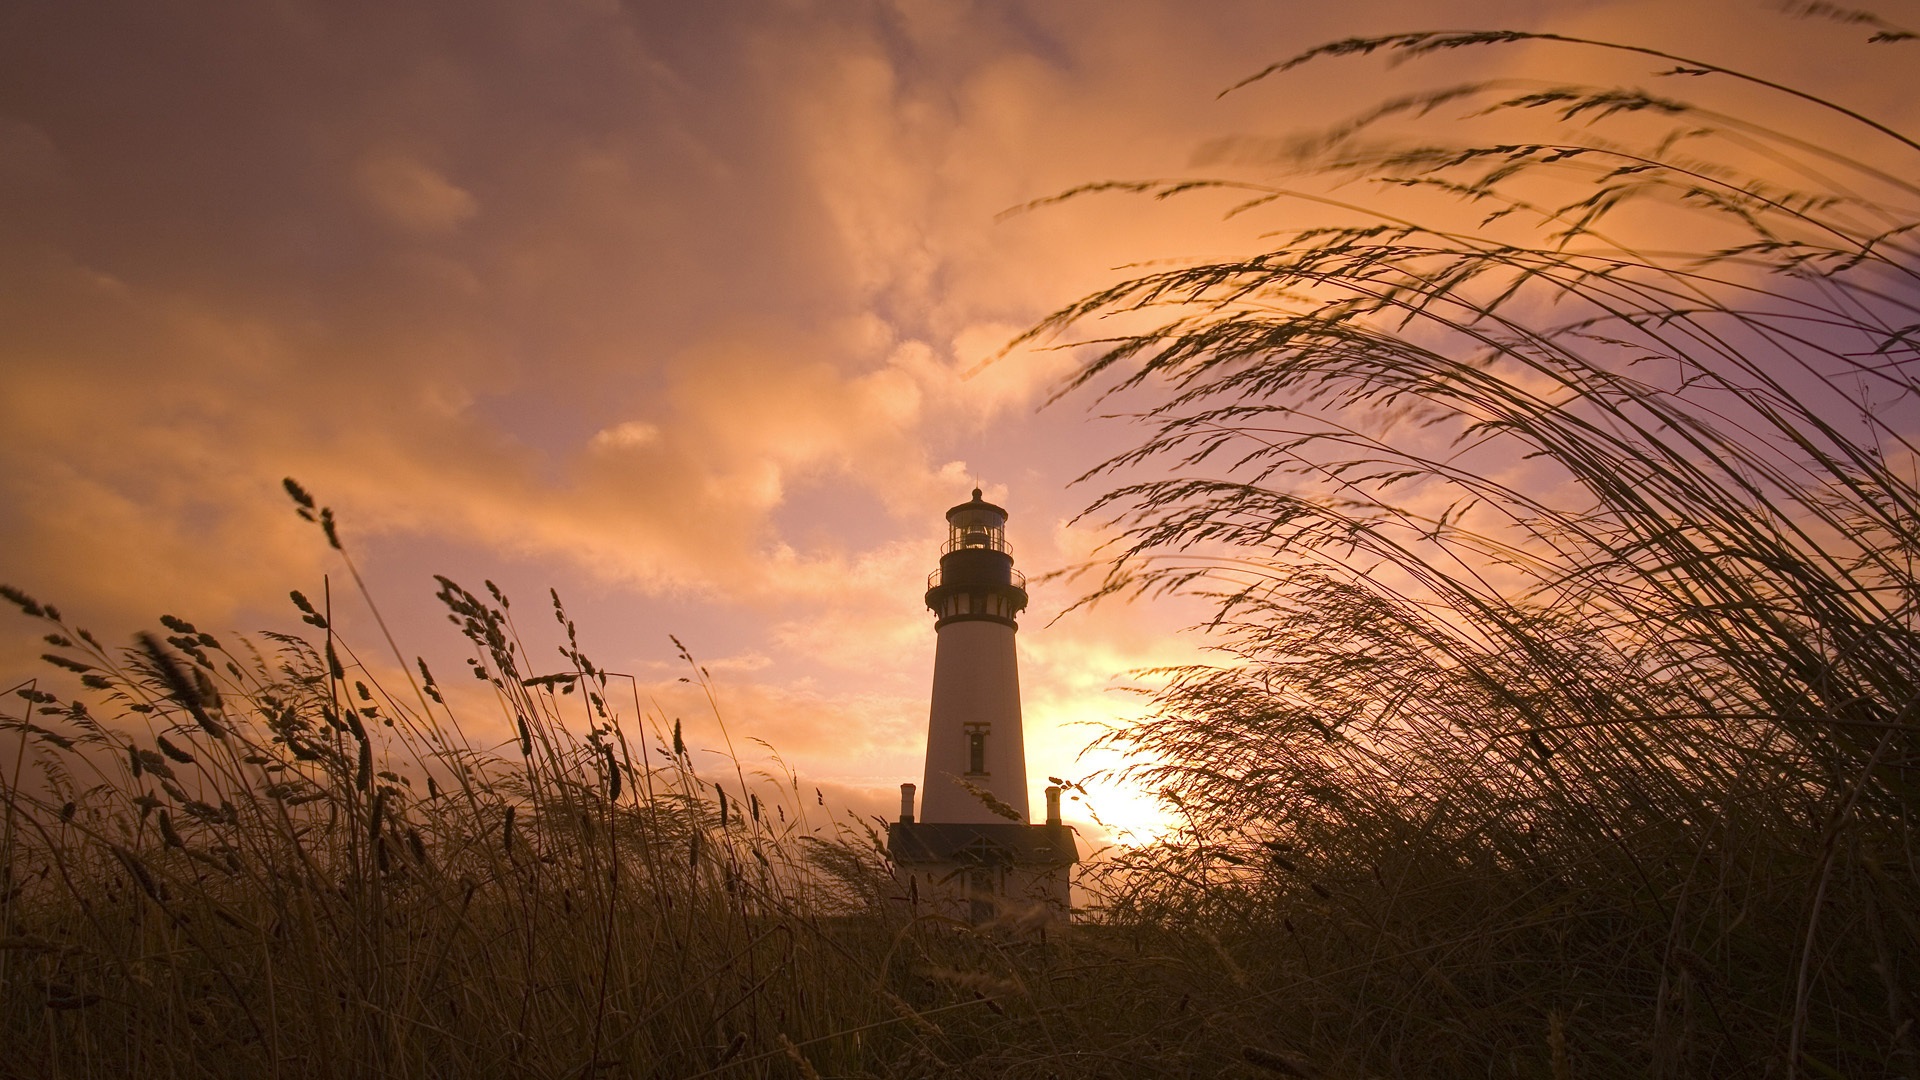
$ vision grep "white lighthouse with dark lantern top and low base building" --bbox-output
[887,488,1079,922]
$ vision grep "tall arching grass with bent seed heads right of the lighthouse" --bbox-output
[1035,16,1920,1076]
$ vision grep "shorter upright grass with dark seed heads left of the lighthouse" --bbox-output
[0,482,1213,1078]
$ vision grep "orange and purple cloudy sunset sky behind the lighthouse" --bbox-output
[0,0,1920,828]
